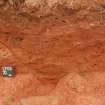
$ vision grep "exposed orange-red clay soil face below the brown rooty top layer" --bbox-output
[0,8,105,105]
